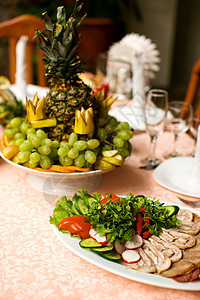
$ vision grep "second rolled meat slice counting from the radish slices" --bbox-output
[143,240,171,273]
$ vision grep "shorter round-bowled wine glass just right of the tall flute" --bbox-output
[164,101,193,158]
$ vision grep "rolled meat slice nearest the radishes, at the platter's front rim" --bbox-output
[127,248,156,273]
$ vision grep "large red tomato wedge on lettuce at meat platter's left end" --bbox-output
[58,215,91,239]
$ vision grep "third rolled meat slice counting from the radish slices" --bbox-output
[149,235,182,262]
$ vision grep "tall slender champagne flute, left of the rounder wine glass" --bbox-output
[142,89,168,169]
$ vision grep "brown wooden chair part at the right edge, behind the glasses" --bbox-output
[185,57,200,116]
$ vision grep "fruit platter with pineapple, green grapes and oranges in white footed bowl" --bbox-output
[0,1,133,194]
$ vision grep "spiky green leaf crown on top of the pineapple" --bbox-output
[34,0,86,83]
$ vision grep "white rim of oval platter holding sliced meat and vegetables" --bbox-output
[52,201,200,291]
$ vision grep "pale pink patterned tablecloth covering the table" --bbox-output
[0,129,200,300]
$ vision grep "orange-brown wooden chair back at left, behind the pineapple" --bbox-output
[0,15,46,86]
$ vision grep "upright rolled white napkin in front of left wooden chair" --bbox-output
[15,36,28,100]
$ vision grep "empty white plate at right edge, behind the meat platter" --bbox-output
[153,157,200,198]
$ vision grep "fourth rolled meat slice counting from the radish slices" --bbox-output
[159,229,196,249]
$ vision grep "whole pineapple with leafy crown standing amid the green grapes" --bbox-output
[34,0,97,140]
